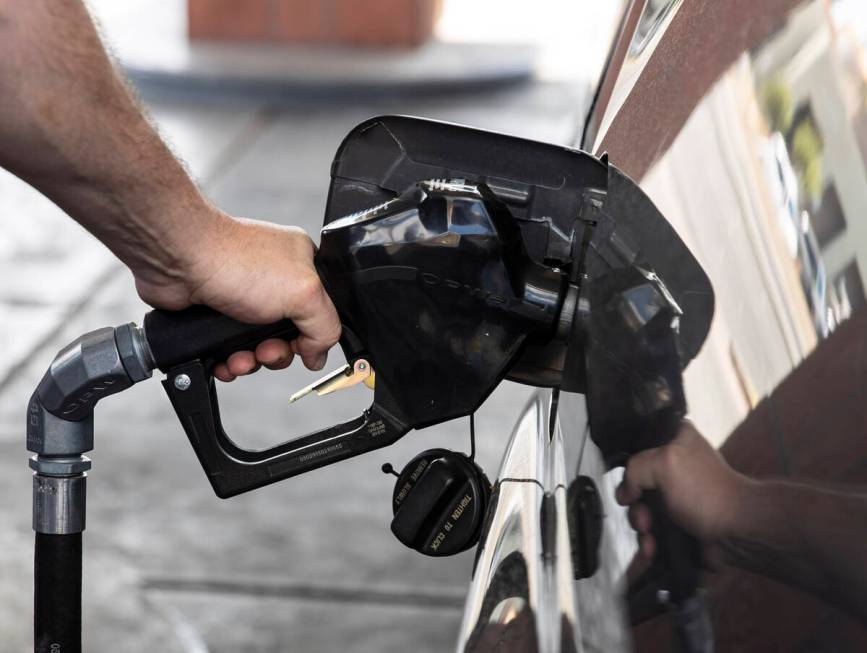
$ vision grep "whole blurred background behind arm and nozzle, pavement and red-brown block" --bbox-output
[0,0,620,653]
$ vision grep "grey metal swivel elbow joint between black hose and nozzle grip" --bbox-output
[27,324,154,535]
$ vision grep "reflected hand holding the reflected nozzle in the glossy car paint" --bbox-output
[616,421,749,563]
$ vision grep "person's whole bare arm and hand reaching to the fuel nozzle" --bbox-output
[0,0,340,370]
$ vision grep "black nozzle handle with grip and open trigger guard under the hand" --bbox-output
[144,306,410,498]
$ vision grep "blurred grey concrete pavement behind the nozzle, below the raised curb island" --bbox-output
[0,75,586,653]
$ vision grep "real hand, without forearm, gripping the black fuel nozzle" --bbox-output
[133,212,340,381]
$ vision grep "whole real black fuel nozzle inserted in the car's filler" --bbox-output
[145,180,574,497]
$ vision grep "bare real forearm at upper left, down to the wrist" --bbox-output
[0,0,222,273]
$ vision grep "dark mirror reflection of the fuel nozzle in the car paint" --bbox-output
[583,266,713,653]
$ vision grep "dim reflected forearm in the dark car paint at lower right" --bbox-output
[721,481,867,620]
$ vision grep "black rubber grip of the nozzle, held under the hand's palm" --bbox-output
[144,306,298,372]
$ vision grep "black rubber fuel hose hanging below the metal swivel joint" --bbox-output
[33,533,81,653]
